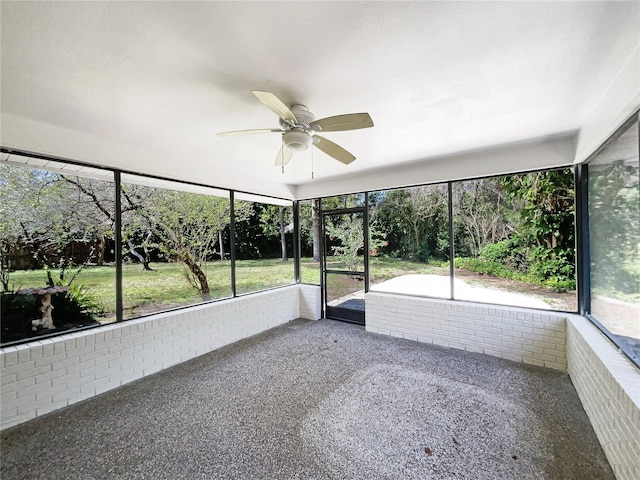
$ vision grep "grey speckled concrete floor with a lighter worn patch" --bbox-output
[0,320,614,480]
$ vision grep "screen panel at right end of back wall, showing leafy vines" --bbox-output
[453,169,577,311]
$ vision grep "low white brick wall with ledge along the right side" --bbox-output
[567,315,640,480]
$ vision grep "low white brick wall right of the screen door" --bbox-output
[365,292,567,371]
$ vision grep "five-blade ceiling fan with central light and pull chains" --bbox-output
[218,90,373,167]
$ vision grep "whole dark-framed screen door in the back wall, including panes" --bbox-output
[322,208,368,325]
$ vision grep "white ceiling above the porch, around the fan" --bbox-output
[0,1,640,198]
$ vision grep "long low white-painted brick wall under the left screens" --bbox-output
[0,285,302,429]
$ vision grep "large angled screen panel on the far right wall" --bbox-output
[588,117,640,361]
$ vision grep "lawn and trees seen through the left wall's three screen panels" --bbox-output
[0,164,293,341]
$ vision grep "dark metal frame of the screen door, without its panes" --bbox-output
[320,206,369,325]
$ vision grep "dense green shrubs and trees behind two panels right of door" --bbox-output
[369,169,576,291]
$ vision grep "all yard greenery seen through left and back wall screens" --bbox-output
[0,165,604,344]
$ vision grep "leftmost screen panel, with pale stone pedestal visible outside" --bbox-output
[0,159,116,343]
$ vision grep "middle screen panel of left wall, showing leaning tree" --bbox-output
[121,175,231,319]
